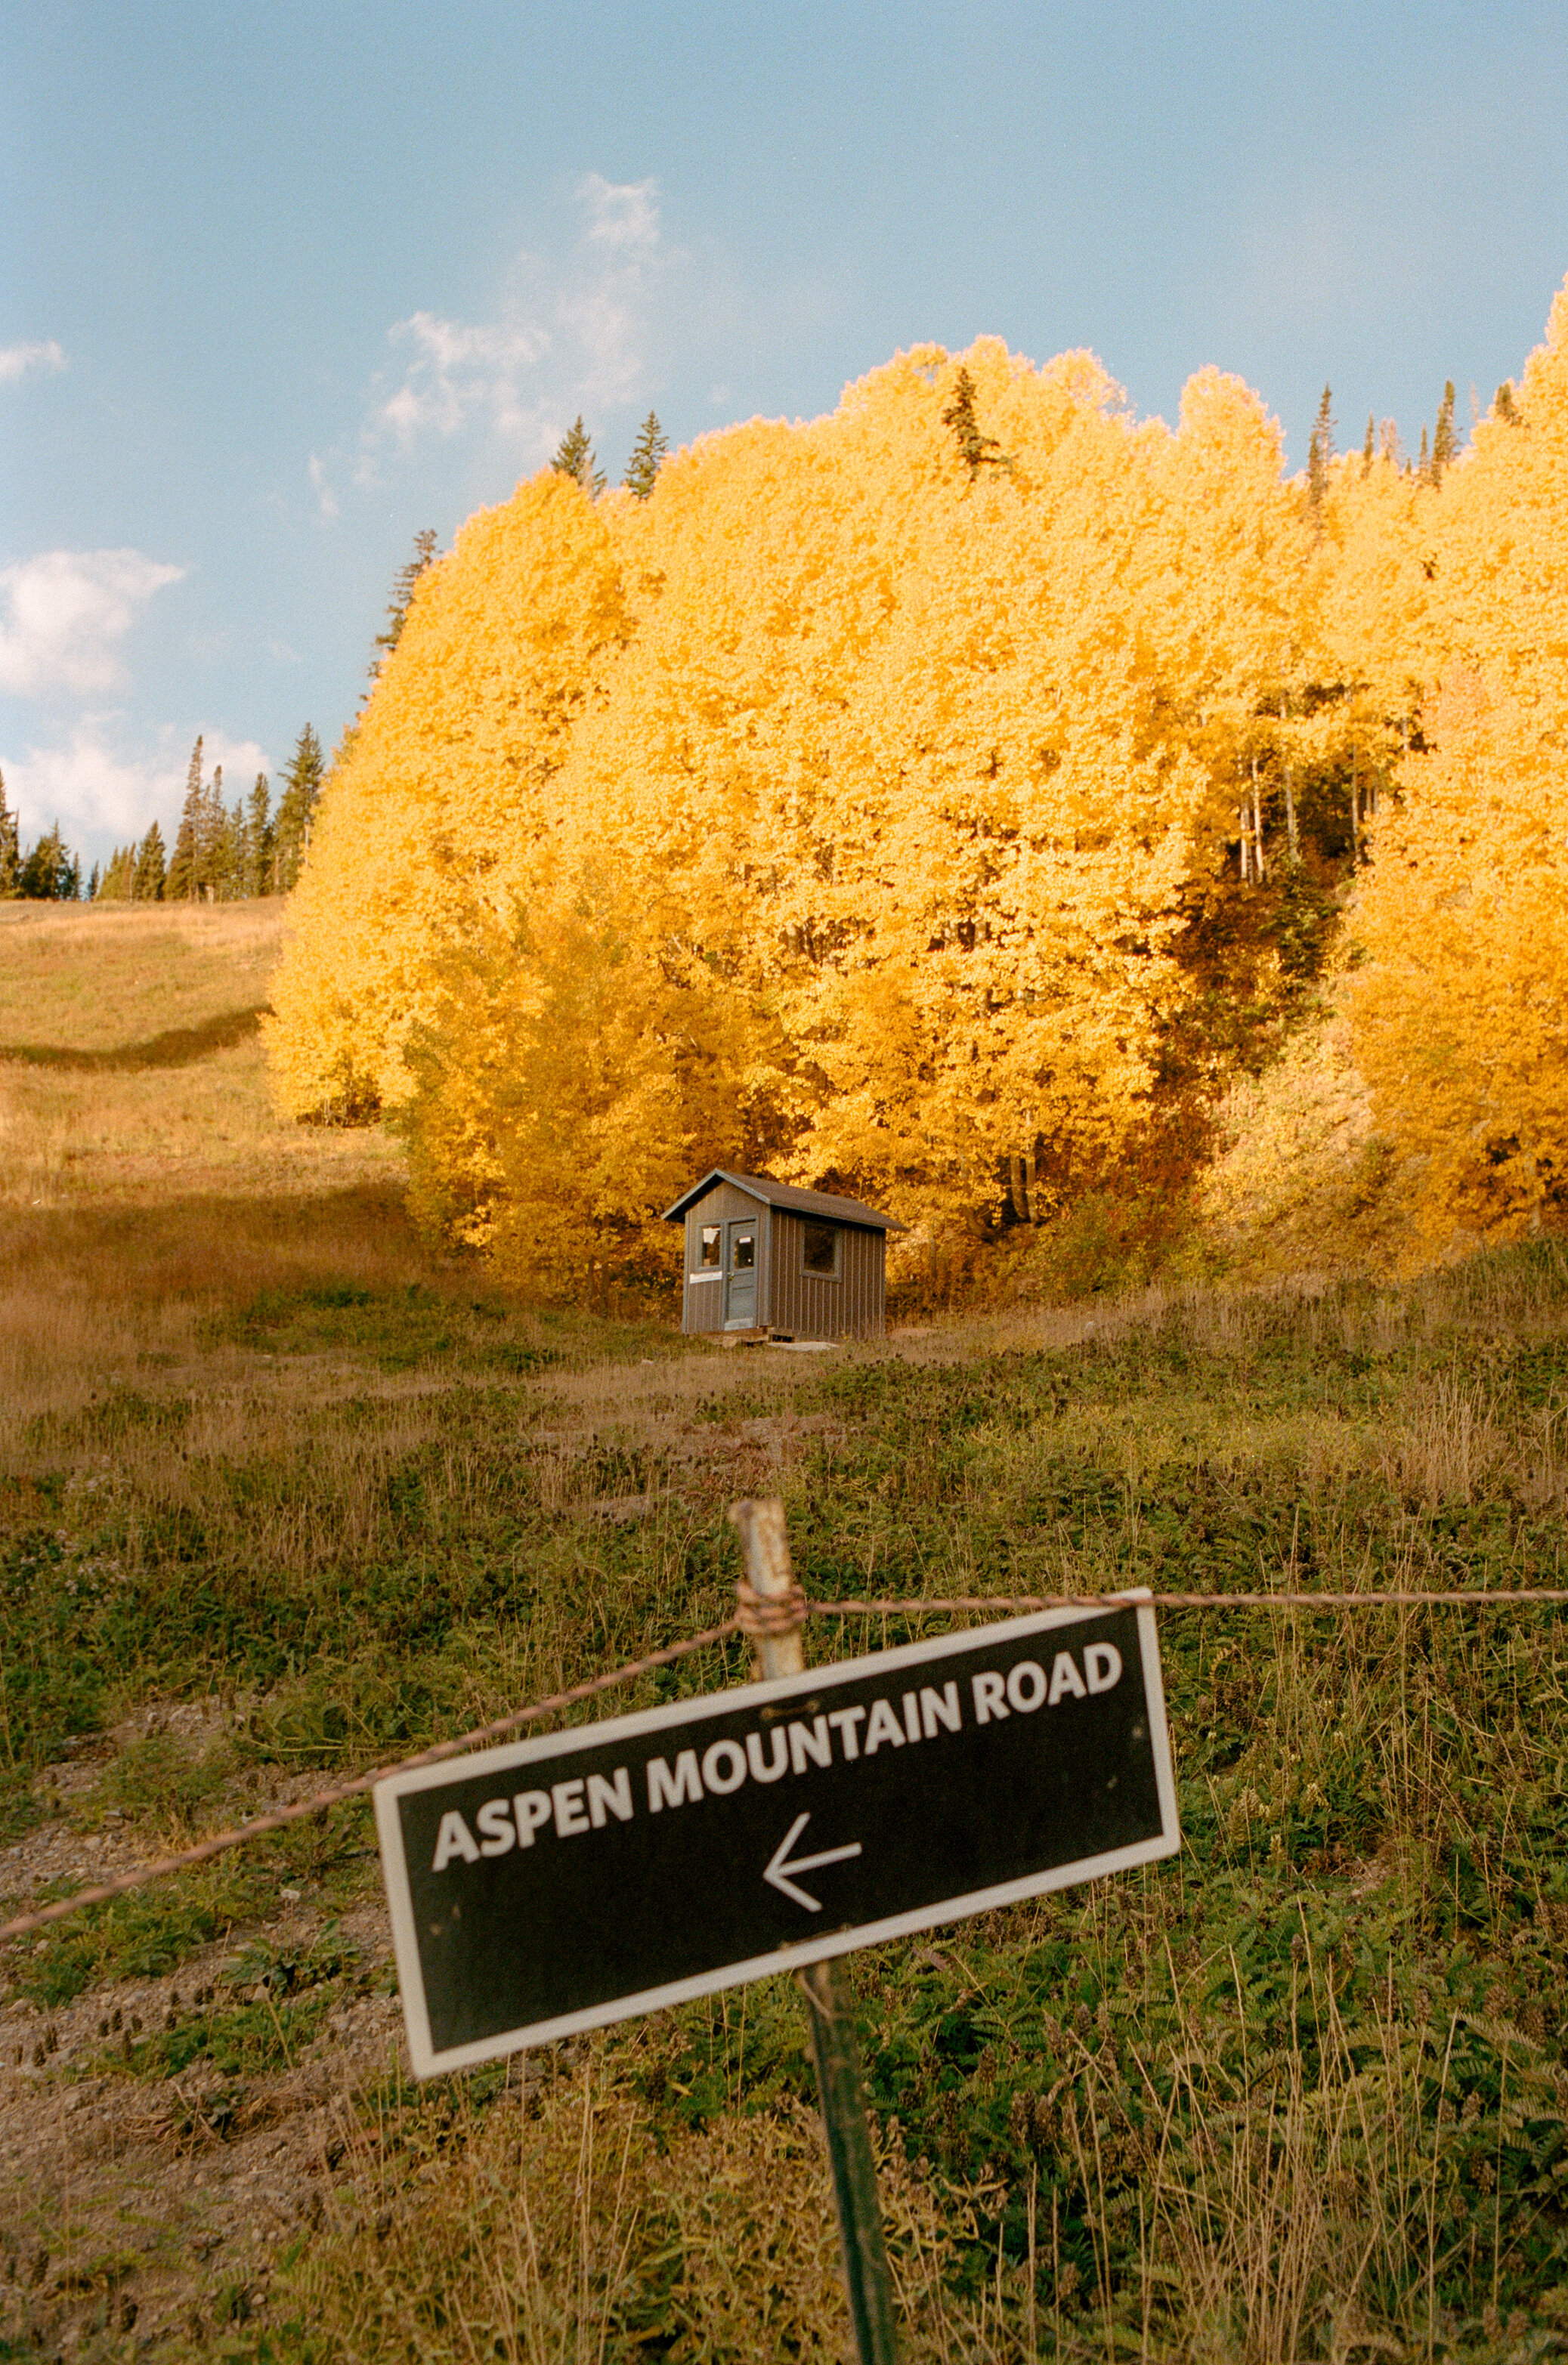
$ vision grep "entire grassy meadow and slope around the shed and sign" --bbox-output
[0,906,1568,2365]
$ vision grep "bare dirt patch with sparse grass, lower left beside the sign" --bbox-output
[0,1700,407,2355]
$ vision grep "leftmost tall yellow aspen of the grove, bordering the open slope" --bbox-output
[270,468,629,1116]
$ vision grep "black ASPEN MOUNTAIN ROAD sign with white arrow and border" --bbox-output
[376,1599,1180,2076]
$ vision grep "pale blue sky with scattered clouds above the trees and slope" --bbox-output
[0,0,1568,861]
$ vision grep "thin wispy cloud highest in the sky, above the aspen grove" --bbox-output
[354,172,688,484]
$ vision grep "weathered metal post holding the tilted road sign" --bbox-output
[731,1502,894,2365]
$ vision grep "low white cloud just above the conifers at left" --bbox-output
[5,714,270,861]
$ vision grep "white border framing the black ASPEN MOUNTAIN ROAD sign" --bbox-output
[373,1587,1183,2079]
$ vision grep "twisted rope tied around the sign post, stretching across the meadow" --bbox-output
[0,1578,1568,1944]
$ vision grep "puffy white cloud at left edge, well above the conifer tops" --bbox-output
[0,551,184,697]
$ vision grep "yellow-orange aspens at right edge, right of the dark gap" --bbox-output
[1350,286,1568,1266]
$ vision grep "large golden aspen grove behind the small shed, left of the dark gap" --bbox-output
[272,341,1461,1287]
